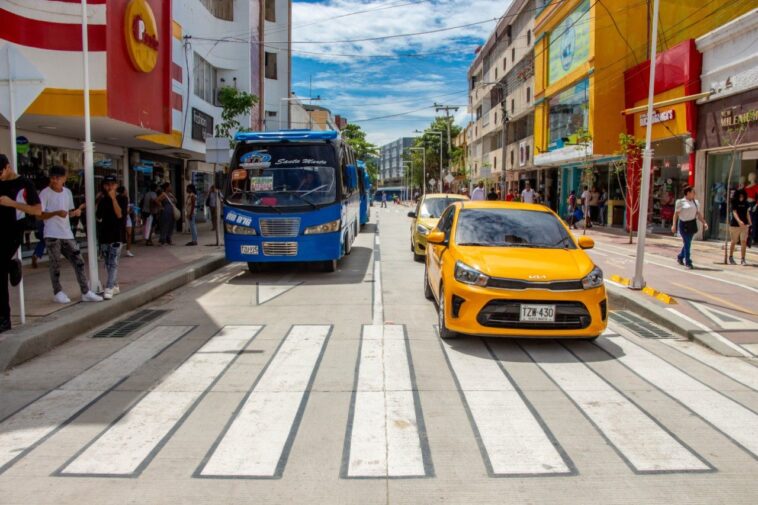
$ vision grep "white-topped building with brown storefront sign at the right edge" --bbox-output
[695,9,758,240]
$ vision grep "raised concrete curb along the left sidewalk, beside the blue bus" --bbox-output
[0,254,227,372]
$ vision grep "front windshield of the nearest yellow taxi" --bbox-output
[455,209,576,249]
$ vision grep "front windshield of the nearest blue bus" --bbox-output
[227,143,339,209]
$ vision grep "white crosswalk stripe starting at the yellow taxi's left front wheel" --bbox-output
[442,339,576,476]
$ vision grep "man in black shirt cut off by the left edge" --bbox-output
[0,154,42,332]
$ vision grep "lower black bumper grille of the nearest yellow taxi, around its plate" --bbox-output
[476,300,592,330]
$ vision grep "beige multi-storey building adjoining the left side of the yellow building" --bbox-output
[468,0,537,198]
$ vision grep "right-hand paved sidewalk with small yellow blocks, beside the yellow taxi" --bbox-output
[584,226,758,357]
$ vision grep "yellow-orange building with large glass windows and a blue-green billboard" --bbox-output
[534,0,751,218]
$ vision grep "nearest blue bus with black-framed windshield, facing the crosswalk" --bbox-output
[224,130,360,272]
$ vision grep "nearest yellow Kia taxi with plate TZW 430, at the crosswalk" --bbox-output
[424,201,608,339]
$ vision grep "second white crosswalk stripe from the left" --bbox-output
[59,326,262,476]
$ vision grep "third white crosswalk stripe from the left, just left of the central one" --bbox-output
[195,325,331,478]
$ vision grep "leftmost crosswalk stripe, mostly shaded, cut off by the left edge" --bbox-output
[0,326,194,473]
